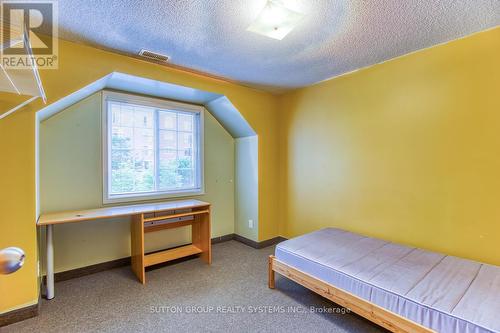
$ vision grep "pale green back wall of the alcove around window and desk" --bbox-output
[40,93,235,272]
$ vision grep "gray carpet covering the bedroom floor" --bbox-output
[1,241,385,333]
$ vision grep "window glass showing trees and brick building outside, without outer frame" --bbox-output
[107,96,199,195]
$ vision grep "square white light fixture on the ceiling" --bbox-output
[247,0,304,40]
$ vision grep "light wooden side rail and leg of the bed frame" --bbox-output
[269,255,435,333]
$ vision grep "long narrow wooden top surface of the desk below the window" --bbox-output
[37,199,210,226]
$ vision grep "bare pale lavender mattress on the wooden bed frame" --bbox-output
[275,228,500,333]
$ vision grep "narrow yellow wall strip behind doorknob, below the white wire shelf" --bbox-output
[0,105,38,313]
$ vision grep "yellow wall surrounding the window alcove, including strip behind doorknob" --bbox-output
[0,40,278,313]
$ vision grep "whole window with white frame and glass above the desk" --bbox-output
[103,92,204,203]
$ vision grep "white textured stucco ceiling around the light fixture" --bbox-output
[59,0,500,91]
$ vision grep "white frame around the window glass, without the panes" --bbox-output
[102,91,205,204]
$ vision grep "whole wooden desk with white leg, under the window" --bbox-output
[37,200,212,299]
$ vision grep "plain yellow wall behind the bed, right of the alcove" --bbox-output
[280,28,500,265]
